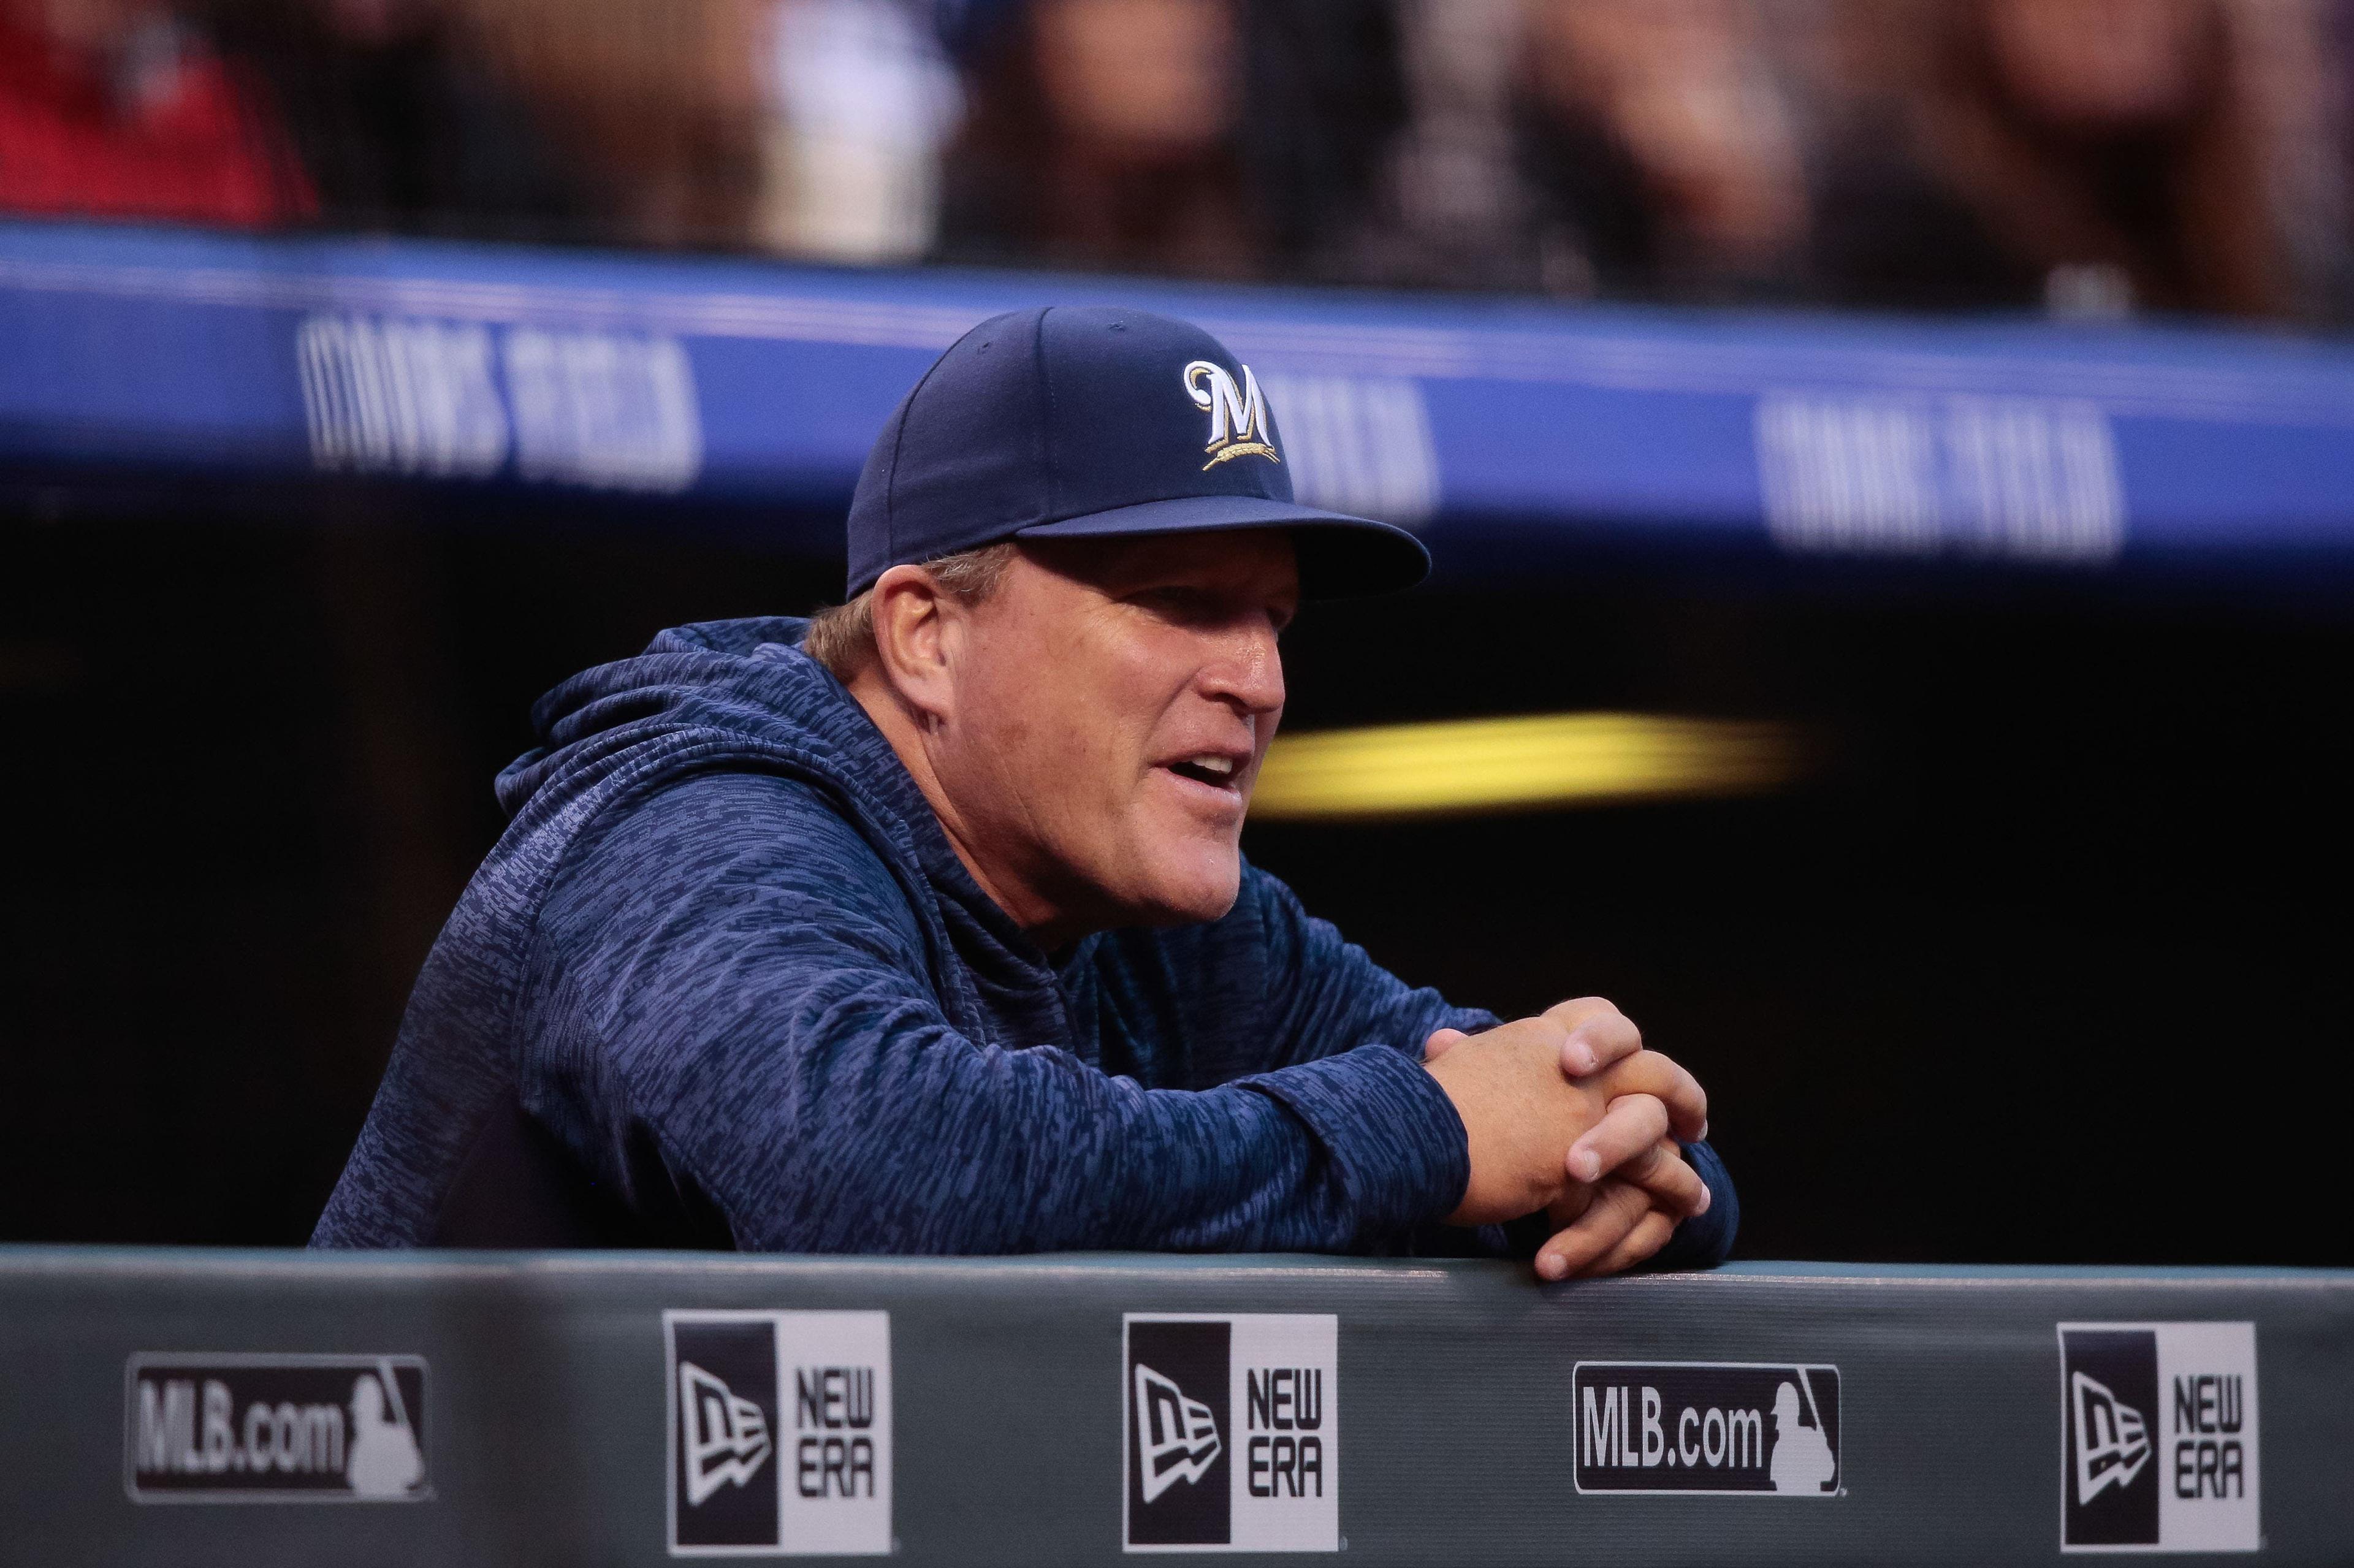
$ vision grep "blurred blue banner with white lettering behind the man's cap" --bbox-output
[0,224,2354,579]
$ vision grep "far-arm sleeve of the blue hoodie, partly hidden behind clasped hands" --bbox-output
[1243,866,1742,1269]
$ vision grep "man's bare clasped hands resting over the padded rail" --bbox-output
[1422,996,1709,1279]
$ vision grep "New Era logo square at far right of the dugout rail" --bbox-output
[2060,1323,2264,1551]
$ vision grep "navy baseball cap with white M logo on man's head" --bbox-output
[850,306,1431,598]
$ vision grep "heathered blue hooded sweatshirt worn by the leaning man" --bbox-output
[313,619,1735,1266]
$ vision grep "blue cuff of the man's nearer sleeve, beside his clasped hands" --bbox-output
[1236,1045,1471,1246]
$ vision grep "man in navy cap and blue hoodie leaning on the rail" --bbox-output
[313,308,1735,1279]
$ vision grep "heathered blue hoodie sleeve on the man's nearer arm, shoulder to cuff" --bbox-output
[532,775,1469,1252]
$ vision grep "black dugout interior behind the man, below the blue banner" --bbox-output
[0,482,2354,1265]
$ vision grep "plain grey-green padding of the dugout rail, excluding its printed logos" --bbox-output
[0,1248,2354,1568]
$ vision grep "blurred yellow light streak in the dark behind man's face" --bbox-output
[1250,714,1801,821]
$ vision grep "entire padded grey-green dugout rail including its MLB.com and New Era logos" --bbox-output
[0,1248,2354,1568]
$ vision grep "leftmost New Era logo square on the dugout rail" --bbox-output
[661,1311,892,1556]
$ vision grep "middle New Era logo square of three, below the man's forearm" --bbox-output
[1121,1311,1339,1551]
